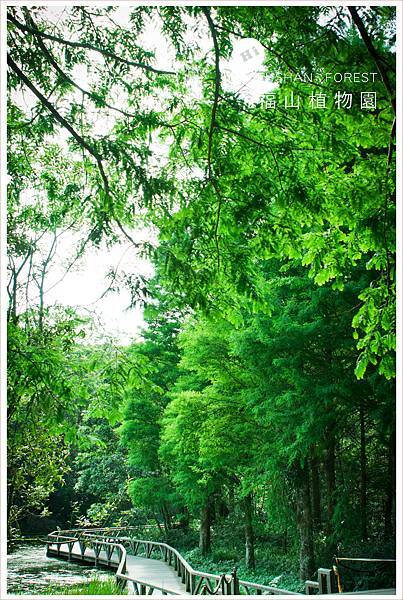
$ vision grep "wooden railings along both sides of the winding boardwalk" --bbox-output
[47,527,303,596]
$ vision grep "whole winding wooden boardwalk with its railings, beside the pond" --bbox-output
[46,527,396,596]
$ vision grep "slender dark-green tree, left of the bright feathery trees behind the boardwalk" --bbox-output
[119,292,186,528]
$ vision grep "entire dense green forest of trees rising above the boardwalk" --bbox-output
[7,5,396,596]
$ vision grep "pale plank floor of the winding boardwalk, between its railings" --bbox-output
[48,542,190,596]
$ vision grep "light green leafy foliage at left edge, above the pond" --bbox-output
[8,312,89,527]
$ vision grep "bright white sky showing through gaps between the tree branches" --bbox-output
[10,6,275,344]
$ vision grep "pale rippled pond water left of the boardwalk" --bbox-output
[7,543,111,594]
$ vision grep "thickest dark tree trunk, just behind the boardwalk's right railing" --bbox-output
[294,465,315,581]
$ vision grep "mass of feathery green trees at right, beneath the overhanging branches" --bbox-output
[160,264,393,580]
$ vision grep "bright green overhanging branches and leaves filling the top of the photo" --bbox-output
[9,7,395,378]
